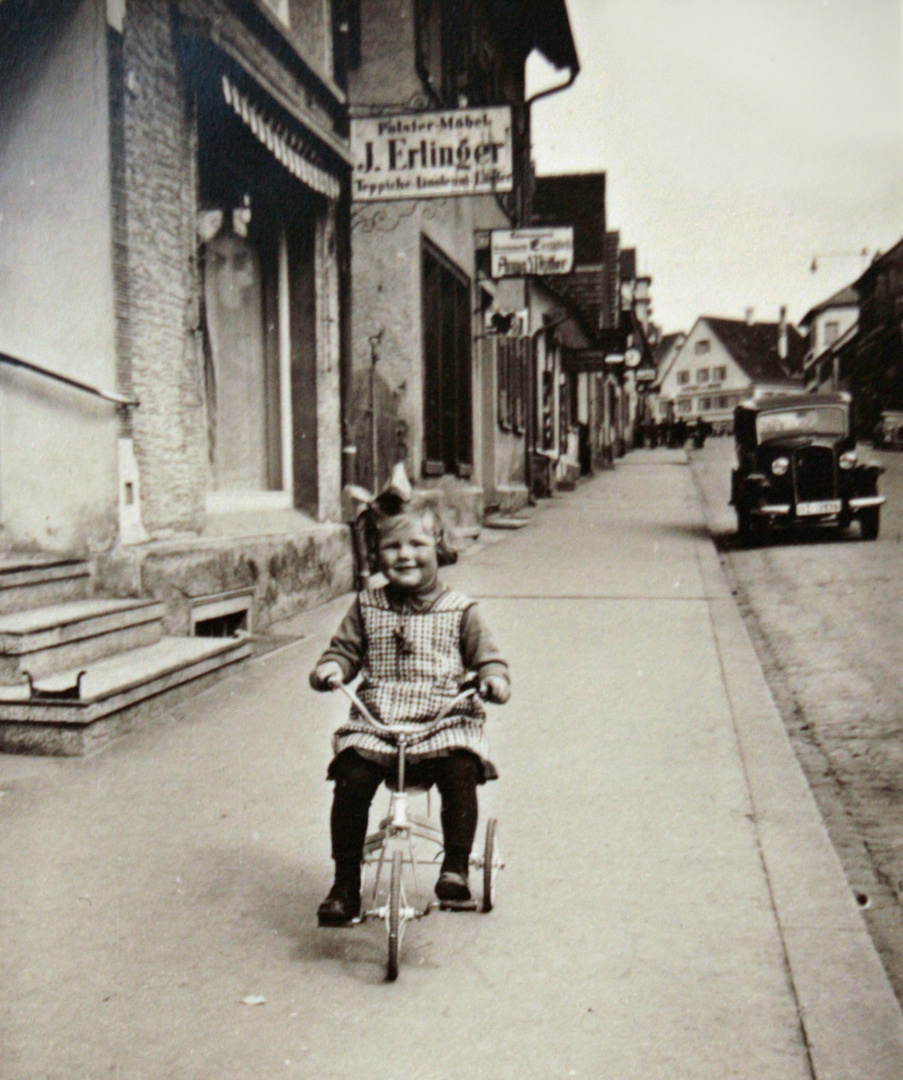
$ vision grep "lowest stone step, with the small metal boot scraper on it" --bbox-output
[0,637,251,756]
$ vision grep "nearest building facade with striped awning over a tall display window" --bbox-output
[0,0,350,624]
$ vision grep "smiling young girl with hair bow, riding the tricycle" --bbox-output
[310,492,511,926]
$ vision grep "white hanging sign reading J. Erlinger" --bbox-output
[351,105,514,202]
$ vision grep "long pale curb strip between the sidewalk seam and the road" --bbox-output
[693,460,903,1080]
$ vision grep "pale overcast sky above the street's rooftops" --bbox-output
[527,0,903,333]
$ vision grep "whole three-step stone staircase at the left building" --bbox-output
[0,556,251,756]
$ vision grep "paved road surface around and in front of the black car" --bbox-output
[692,440,903,1000]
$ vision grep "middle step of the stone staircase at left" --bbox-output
[0,597,165,683]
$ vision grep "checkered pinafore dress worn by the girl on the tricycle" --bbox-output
[333,589,495,775]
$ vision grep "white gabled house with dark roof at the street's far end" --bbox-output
[660,315,805,424]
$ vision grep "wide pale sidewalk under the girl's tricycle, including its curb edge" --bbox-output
[0,450,903,1080]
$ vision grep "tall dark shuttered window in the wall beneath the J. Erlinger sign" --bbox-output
[422,240,473,476]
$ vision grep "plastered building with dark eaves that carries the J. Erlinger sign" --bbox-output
[346,0,579,518]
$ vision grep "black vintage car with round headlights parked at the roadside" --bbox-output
[730,393,885,540]
